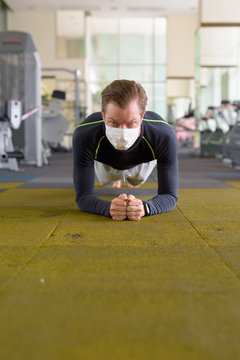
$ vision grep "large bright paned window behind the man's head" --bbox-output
[86,17,166,117]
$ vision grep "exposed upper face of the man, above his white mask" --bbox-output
[102,101,145,135]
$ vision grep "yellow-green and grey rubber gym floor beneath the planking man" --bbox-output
[0,154,240,360]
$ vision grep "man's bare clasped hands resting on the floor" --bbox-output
[110,194,145,220]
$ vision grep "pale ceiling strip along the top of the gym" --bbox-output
[5,0,198,16]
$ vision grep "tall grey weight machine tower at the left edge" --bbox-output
[0,31,42,170]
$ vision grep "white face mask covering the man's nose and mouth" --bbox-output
[105,124,140,150]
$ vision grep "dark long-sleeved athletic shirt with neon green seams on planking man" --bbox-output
[73,111,178,216]
